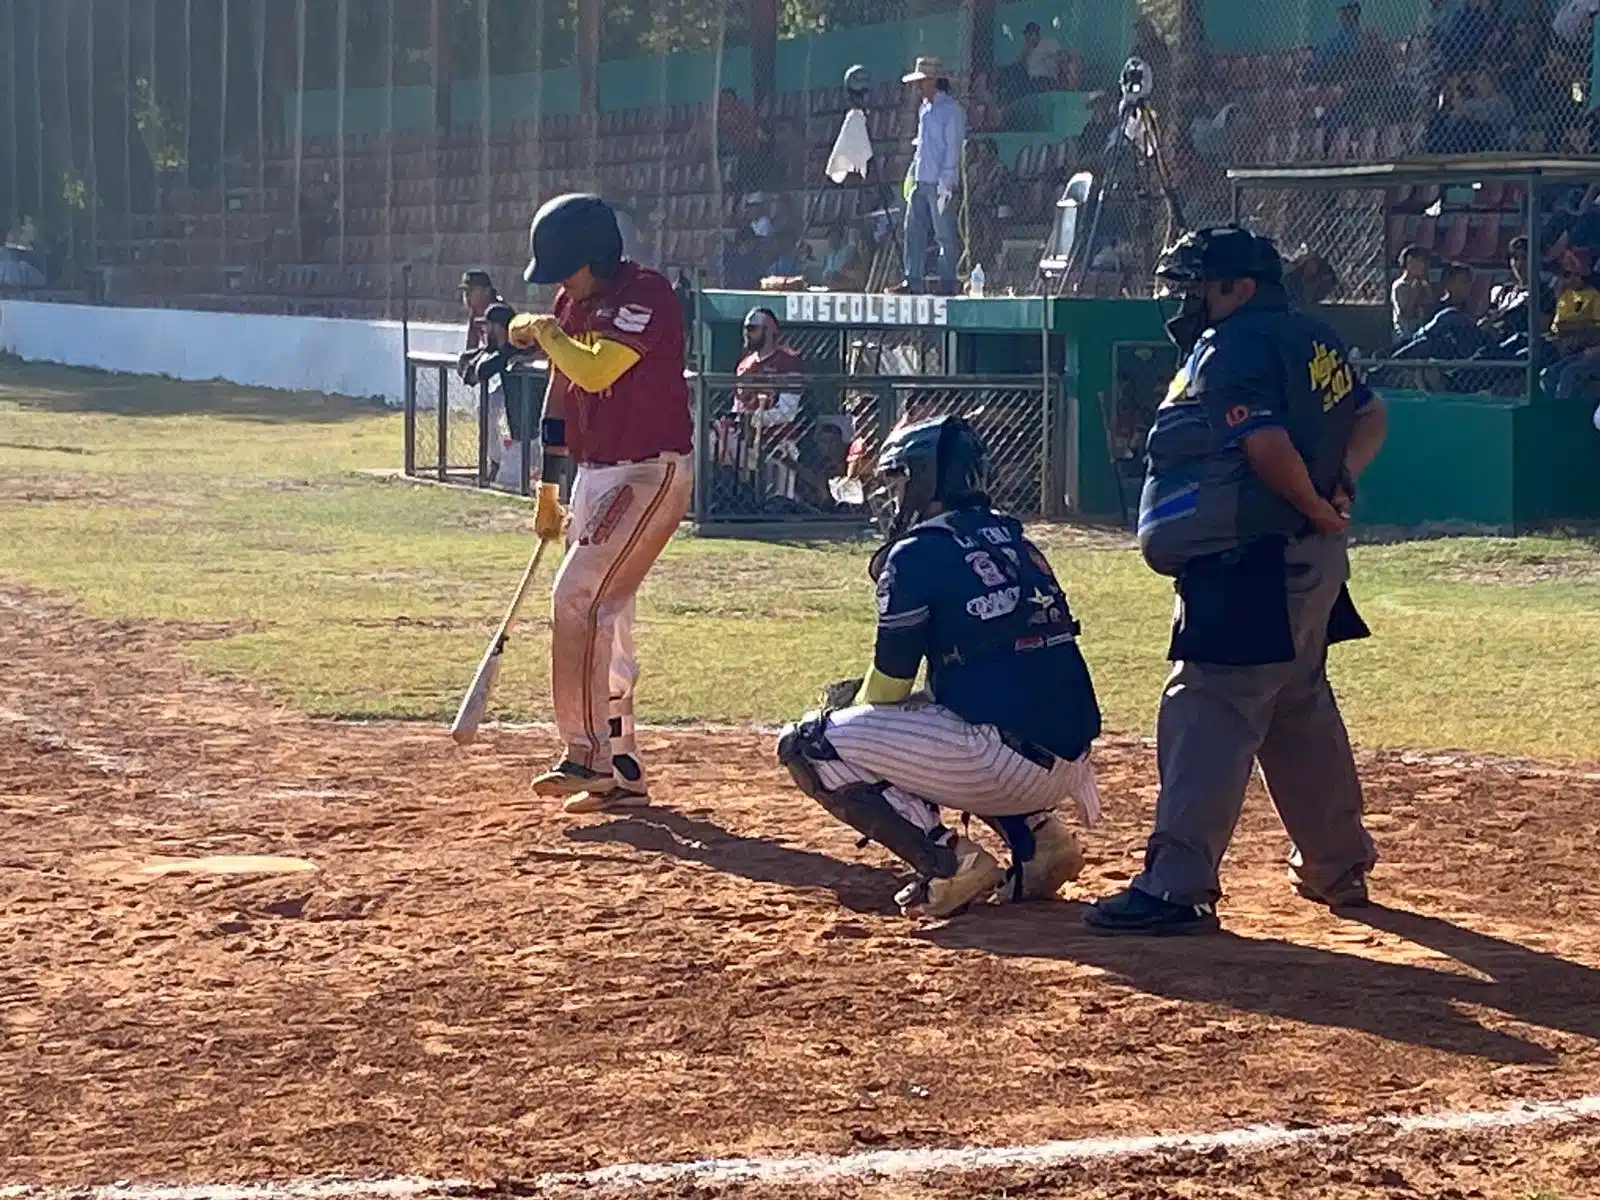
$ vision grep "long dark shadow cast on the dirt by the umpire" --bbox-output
[918,902,1600,1064]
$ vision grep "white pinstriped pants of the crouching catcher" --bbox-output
[811,699,1099,832]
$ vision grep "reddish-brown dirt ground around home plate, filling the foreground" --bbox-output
[0,590,1600,1200]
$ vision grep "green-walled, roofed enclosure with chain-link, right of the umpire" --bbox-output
[1227,155,1600,530]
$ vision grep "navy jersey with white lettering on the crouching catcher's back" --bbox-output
[874,509,1101,758]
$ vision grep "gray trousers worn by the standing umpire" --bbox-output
[1133,534,1376,904]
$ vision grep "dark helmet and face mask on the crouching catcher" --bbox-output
[867,416,989,579]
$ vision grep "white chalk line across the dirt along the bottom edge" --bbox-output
[0,1094,1600,1200]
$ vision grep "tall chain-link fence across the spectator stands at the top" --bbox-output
[0,0,1594,318]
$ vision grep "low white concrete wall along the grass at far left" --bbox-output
[0,299,466,403]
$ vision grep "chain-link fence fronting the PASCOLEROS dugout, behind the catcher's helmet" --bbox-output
[696,374,1054,523]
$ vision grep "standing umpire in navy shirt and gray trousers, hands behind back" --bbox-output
[1085,226,1386,934]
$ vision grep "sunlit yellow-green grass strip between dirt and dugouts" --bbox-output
[0,362,1600,758]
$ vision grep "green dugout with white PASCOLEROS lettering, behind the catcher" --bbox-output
[694,290,1176,525]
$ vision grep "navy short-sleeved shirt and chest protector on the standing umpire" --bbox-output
[1139,288,1373,574]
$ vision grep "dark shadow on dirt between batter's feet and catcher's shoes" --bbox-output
[566,808,906,912]
